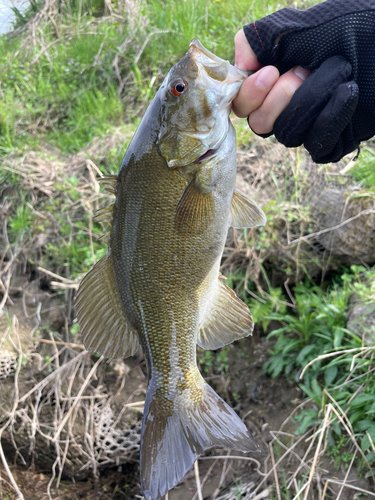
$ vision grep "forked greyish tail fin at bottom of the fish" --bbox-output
[141,381,259,500]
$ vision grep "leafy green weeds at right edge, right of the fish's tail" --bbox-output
[264,272,375,463]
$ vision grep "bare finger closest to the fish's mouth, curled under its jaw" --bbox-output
[232,66,279,118]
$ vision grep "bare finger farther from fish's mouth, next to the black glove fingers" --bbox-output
[249,66,311,134]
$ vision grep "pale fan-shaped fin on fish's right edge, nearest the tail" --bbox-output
[197,281,254,349]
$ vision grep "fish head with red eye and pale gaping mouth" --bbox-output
[158,39,249,168]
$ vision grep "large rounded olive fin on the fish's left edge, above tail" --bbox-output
[76,254,139,358]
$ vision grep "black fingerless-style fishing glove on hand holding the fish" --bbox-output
[244,0,375,163]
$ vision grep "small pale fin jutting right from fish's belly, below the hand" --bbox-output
[229,189,266,229]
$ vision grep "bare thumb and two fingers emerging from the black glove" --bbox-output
[232,29,311,135]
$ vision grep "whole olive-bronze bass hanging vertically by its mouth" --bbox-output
[76,39,266,500]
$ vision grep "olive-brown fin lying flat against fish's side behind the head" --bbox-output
[174,176,214,234]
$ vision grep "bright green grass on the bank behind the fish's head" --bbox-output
[0,0,320,155]
